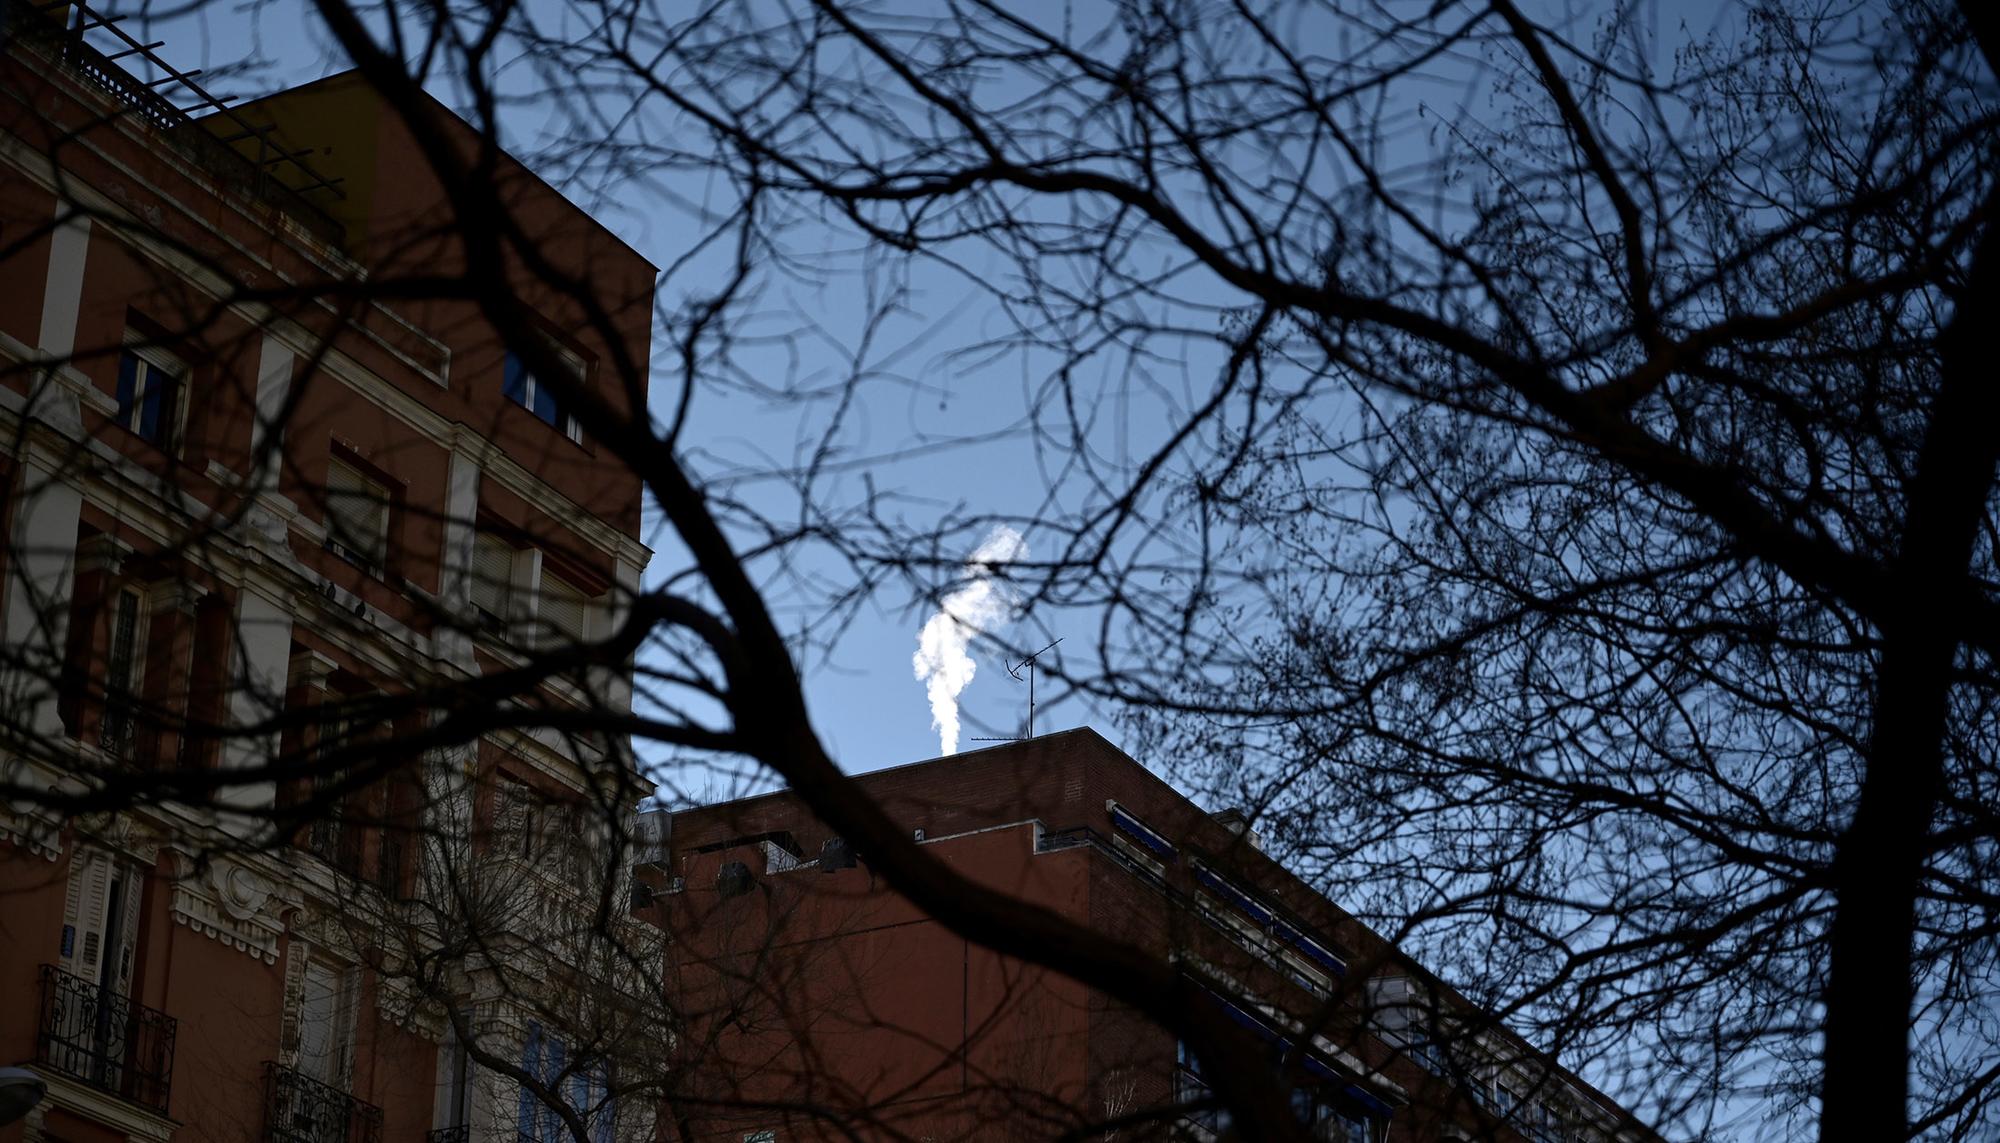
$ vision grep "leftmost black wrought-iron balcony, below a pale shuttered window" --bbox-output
[34,965,176,1115]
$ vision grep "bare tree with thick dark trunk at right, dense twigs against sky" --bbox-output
[454,2,1996,1137]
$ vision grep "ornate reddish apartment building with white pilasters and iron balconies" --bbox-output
[0,0,654,1143]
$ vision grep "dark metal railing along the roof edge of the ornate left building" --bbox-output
[0,0,344,246]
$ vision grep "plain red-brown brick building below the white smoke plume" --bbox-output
[646,729,1654,1143]
